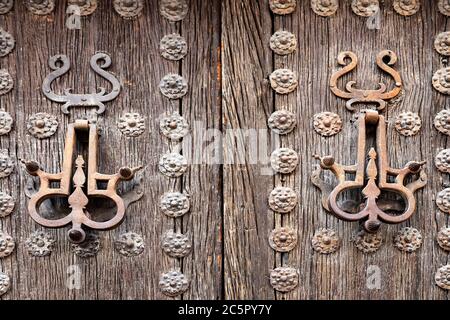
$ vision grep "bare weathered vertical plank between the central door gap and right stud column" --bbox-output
[222,0,274,299]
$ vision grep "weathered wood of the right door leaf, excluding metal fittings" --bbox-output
[222,0,449,299]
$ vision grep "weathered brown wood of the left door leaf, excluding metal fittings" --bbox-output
[0,0,222,299]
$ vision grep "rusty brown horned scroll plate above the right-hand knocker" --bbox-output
[330,50,402,111]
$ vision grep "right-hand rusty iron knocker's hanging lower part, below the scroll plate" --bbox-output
[312,110,427,232]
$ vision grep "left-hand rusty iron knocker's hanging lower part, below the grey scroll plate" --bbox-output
[24,120,142,243]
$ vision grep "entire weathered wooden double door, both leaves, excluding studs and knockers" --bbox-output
[0,0,449,299]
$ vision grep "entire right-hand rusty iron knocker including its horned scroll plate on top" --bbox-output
[311,50,427,233]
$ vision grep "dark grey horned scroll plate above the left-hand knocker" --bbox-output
[42,53,120,114]
